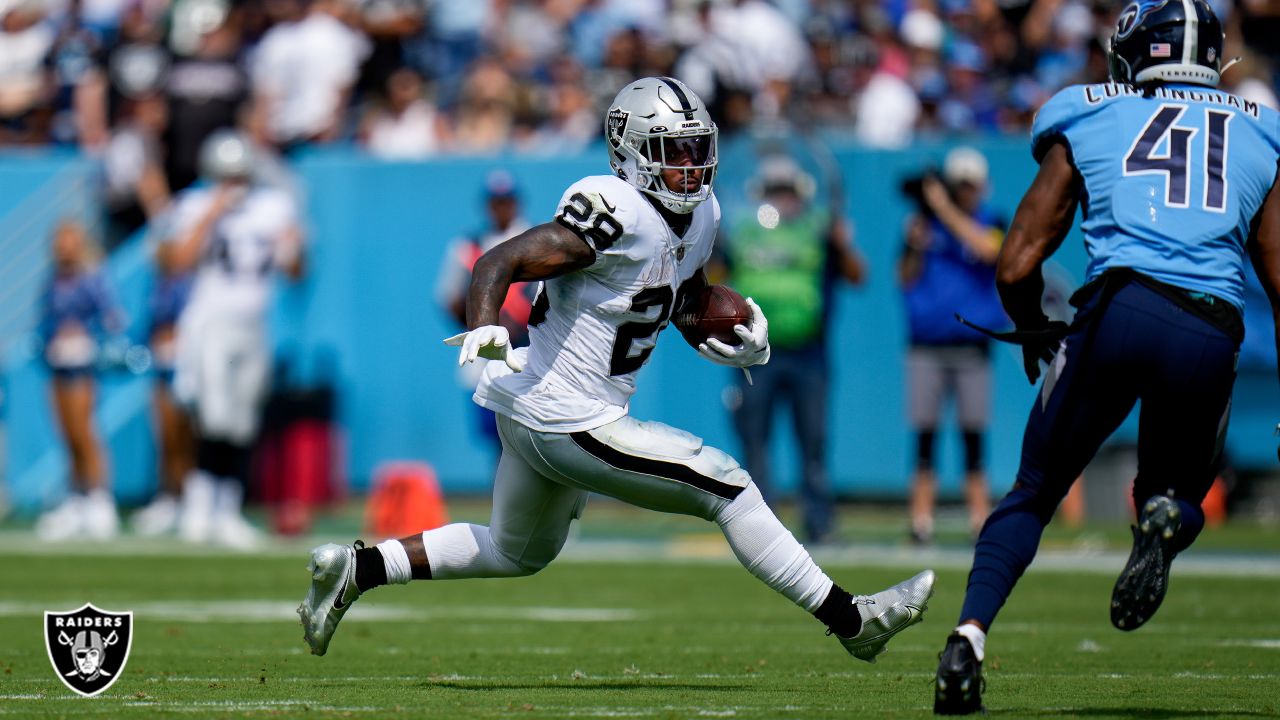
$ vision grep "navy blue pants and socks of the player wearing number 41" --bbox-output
[960,283,1239,628]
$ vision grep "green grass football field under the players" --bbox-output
[0,502,1280,719]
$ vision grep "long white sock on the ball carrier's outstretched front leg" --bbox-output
[716,483,835,612]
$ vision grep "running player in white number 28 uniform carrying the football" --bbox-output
[298,77,933,661]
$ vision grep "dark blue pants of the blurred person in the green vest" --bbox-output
[733,343,832,542]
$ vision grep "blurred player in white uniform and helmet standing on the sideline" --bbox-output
[160,131,302,547]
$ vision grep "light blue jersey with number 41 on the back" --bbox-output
[1032,83,1280,307]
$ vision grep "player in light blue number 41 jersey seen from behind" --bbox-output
[934,0,1280,715]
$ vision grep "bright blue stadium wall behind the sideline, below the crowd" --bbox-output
[0,138,1280,509]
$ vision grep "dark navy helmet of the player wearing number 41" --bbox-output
[1108,0,1224,87]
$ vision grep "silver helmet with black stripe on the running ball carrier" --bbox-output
[604,77,719,214]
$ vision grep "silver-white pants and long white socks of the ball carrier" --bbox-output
[422,415,832,611]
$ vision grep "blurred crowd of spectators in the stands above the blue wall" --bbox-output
[0,0,1280,227]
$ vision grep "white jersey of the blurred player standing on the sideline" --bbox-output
[164,187,297,322]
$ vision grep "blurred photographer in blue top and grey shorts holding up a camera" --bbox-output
[899,147,1009,544]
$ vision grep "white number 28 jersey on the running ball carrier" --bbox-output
[475,176,719,433]
